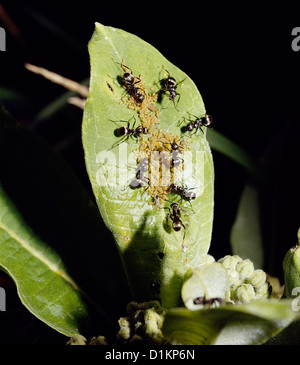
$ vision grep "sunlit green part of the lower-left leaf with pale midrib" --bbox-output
[0,186,87,336]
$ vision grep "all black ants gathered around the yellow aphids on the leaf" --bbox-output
[108,63,212,235]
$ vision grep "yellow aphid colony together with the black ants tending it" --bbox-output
[112,61,212,231]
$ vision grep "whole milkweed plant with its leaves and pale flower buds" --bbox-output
[0,23,300,345]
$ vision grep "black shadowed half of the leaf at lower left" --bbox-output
[0,106,130,336]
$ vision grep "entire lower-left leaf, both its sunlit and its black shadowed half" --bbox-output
[0,107,125,336]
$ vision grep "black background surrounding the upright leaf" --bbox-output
[0,0,300,342]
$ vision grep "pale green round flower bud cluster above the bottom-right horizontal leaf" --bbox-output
[219,255,271,304]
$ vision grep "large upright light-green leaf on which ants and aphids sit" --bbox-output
[83,23,214,307]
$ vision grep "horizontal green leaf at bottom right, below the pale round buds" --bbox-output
[163,300,300,345]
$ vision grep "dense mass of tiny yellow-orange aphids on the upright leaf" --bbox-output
[121,60,190,207]
